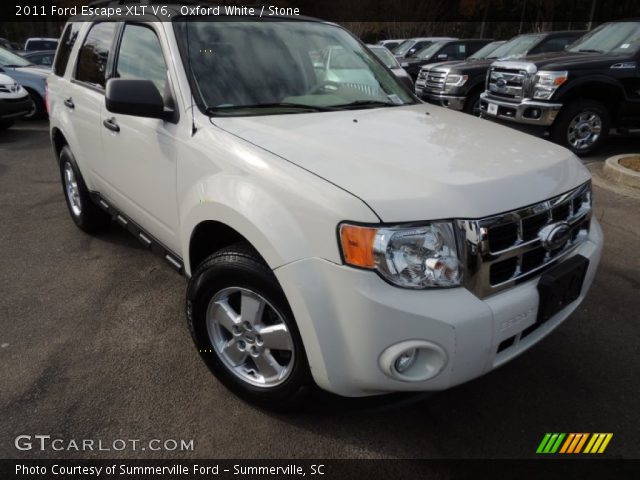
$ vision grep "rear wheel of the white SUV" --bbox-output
[60,145,111,233]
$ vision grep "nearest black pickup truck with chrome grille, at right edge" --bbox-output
[480,20,640,155]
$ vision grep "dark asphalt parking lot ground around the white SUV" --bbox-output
[0,118,640,458]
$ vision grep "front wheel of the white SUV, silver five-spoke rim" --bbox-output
[186,243,312,411]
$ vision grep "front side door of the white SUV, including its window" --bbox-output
[97,23,179,252]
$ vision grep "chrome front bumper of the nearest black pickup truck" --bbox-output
[480,93,562,127]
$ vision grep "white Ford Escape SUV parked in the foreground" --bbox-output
[48,7,603,408]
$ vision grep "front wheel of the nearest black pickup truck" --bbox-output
[551,100,611,156]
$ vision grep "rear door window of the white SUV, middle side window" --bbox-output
[76,22,116,88]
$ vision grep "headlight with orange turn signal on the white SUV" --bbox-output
[340,222,462,289]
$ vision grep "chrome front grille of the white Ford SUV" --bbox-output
[458,182,591,298]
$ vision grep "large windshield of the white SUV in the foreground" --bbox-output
[175,20,415,115]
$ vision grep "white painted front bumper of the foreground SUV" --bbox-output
[275,219,603,396]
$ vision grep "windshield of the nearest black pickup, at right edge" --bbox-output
[568,22,640,54]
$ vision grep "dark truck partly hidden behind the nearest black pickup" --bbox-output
[416,30,585,115]
